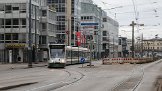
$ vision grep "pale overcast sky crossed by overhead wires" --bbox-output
[93,0,162,39]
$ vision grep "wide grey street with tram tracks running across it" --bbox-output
[0,60,162,91]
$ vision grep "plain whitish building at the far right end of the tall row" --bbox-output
[101,14,119,58]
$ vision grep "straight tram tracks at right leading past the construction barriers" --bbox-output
[111,60,162,91]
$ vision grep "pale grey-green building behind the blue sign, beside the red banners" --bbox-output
[80,0,104,58]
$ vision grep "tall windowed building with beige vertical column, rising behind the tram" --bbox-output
[47,0,81,46]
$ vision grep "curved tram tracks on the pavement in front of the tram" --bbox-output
[1,69,84,91]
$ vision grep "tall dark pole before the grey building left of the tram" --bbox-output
[28,0,32,68]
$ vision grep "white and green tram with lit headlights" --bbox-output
[48,44,90,68]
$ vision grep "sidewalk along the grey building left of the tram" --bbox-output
[0,62,47,71]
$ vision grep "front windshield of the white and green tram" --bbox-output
[51,49,65,58]
